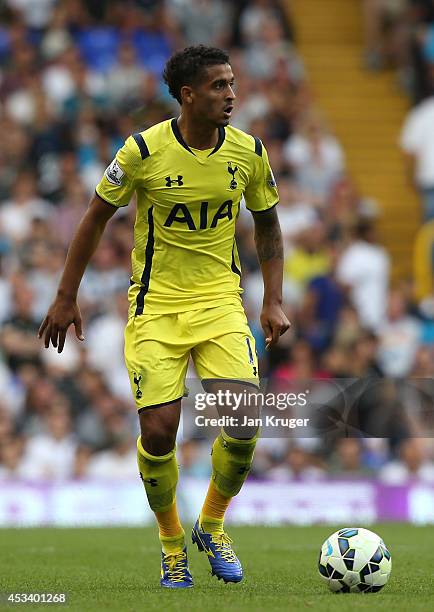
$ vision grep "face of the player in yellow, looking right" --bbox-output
[191,64,235,127]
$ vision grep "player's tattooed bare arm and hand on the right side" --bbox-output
[252,208,290,349]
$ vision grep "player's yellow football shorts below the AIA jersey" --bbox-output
[125,305,259,409]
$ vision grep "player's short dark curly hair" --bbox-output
[163,45,229,104]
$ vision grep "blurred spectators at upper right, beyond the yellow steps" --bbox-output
[363,0,434,221]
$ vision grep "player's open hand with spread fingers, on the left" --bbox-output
[38,297,84,353]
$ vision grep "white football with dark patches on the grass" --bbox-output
[318,527,392,593]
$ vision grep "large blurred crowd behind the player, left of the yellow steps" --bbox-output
[0,0,434,483]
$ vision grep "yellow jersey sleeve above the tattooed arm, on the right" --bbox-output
[244,138,279,212]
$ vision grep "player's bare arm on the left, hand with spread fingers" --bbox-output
[38,194,116,353]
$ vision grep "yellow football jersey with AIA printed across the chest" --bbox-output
[96,119,278,316]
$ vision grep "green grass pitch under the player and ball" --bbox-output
[0,524,434,612]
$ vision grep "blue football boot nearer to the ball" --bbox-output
[191,519,243,582]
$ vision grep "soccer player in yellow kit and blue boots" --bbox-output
[39,45,289,588]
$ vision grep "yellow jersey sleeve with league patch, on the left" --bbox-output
[95,136,142,208]
